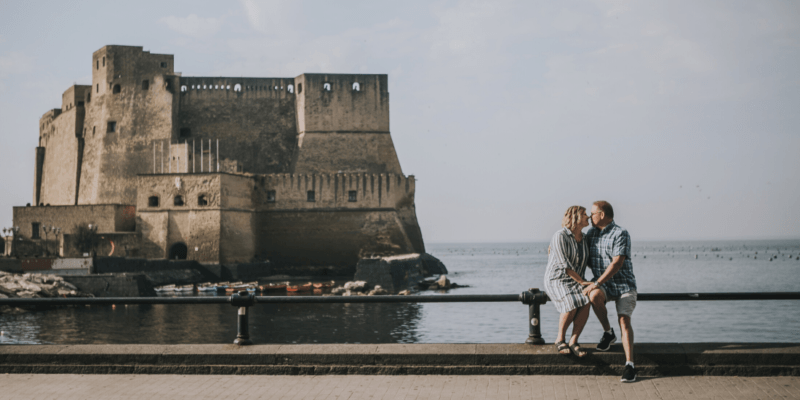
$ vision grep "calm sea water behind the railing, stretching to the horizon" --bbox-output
[0,240,800,344]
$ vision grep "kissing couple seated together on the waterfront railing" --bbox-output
[544,201,636,382]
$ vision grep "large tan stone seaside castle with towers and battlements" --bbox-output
[13,46,425,265]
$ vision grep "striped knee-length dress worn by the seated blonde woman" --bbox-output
[544,228,589,313]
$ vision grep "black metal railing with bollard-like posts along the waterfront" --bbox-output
[0,289,800,345]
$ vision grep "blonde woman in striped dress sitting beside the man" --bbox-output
[544,206,589,357]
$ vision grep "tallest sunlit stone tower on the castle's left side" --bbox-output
[78,46,178,204]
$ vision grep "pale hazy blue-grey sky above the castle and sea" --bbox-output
[0,0,800,242]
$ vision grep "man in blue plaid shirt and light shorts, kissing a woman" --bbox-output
[583,200,637,382]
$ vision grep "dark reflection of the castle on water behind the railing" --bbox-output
[0,304,420,344]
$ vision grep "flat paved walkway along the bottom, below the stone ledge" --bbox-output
[0,374,800,400]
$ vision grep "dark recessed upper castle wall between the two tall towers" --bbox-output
[178,77,297,174]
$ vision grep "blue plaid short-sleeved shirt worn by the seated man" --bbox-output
[583,221,636,298]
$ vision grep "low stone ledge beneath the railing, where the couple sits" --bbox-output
[0,343,800,377]
